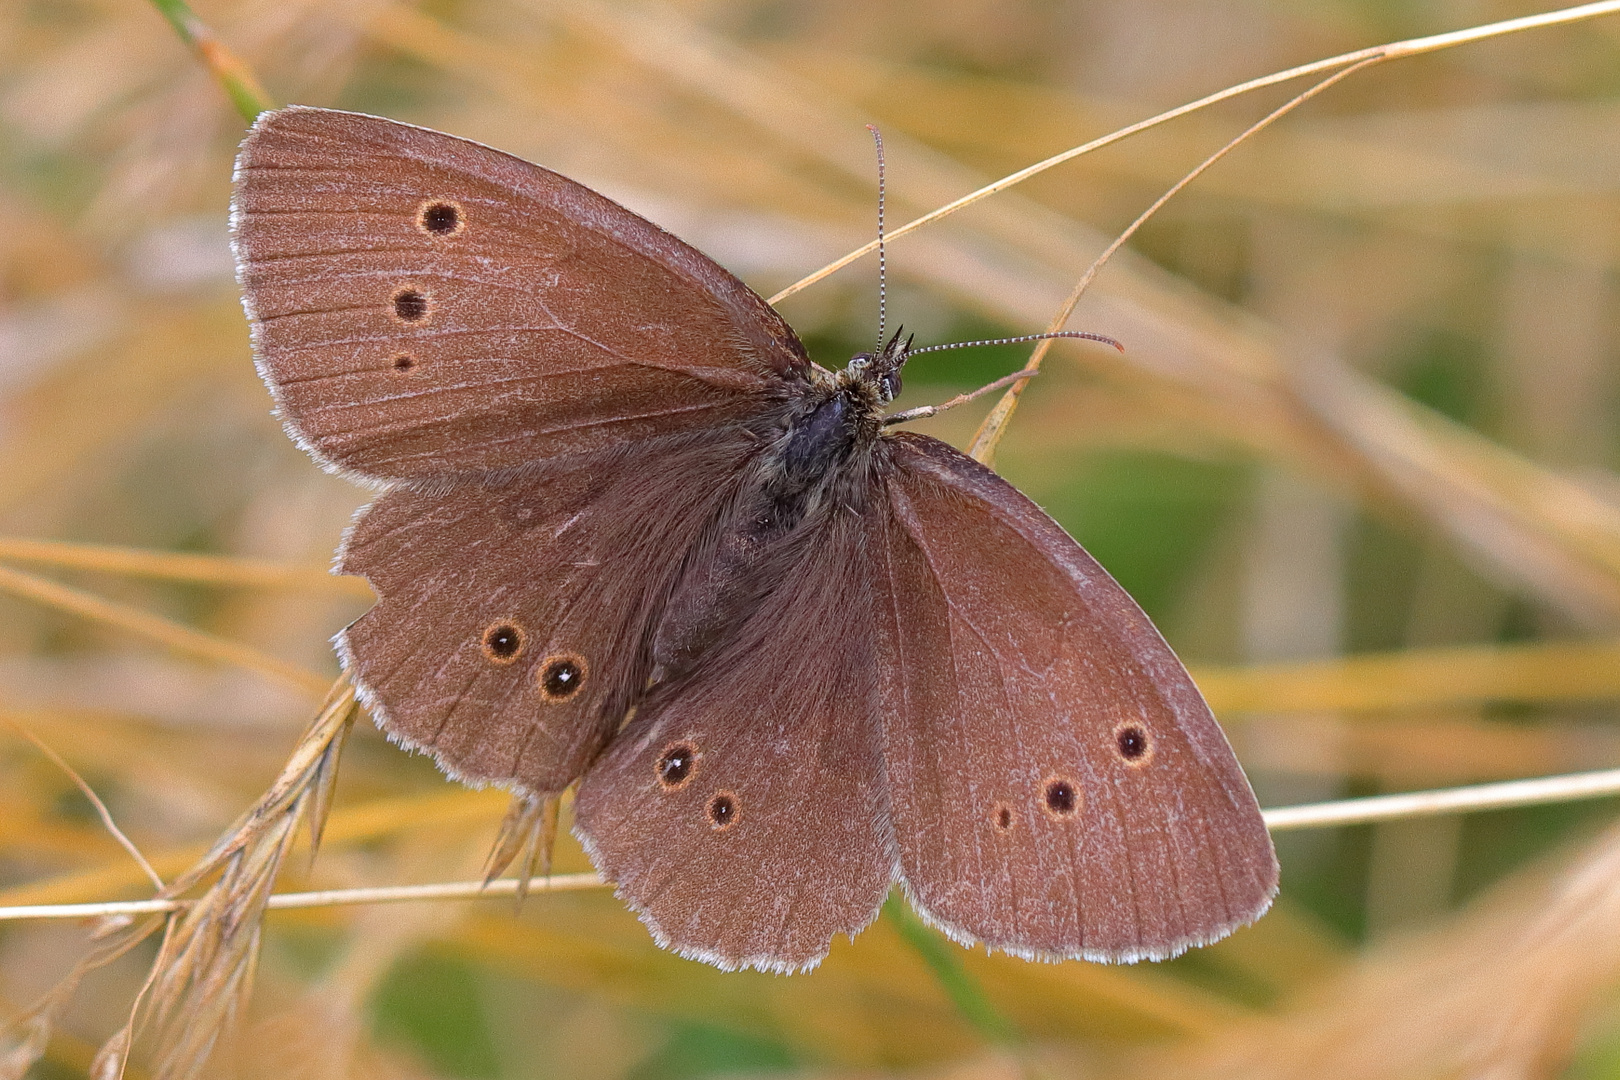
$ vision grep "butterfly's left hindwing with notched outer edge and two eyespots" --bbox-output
[339,431,753,793]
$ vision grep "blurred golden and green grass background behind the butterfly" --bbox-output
[0,0,1620,1080]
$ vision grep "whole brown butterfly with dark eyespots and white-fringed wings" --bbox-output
[233,107,1277,972]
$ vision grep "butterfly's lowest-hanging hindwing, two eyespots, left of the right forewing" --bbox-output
[573,510,894,972]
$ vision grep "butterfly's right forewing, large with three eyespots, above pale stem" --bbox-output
[872,434,1277,962]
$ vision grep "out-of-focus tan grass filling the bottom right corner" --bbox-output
[1131,827,1620,1080]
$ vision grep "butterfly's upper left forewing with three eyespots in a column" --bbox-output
[232,107,810,479]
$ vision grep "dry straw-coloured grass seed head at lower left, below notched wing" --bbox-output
[0,678,358,1080]
